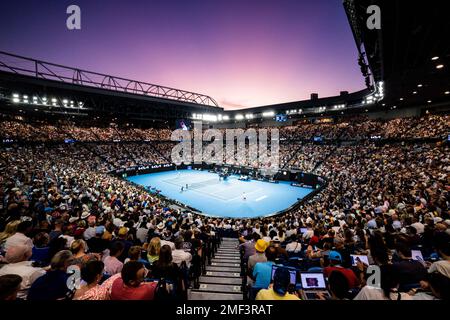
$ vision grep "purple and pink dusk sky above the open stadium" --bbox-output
[0,0,364,109]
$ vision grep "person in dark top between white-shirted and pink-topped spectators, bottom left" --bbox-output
[27,250,72,300]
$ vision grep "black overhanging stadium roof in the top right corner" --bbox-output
[344,0,450,108]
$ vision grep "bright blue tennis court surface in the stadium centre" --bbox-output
[127,170,313,218]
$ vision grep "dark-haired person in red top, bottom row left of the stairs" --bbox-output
[111,261,157,300]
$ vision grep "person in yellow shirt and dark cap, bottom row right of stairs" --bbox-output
[256,268,300,300]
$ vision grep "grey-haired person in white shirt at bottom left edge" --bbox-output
[0,244,45,299]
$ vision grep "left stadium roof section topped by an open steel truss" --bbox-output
[0,51,223,123]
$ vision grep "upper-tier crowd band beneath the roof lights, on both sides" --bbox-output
[0,115,450,142]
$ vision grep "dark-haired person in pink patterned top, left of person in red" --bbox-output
[73,260,109,300]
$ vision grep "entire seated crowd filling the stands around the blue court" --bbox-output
[0,111,450,300]
